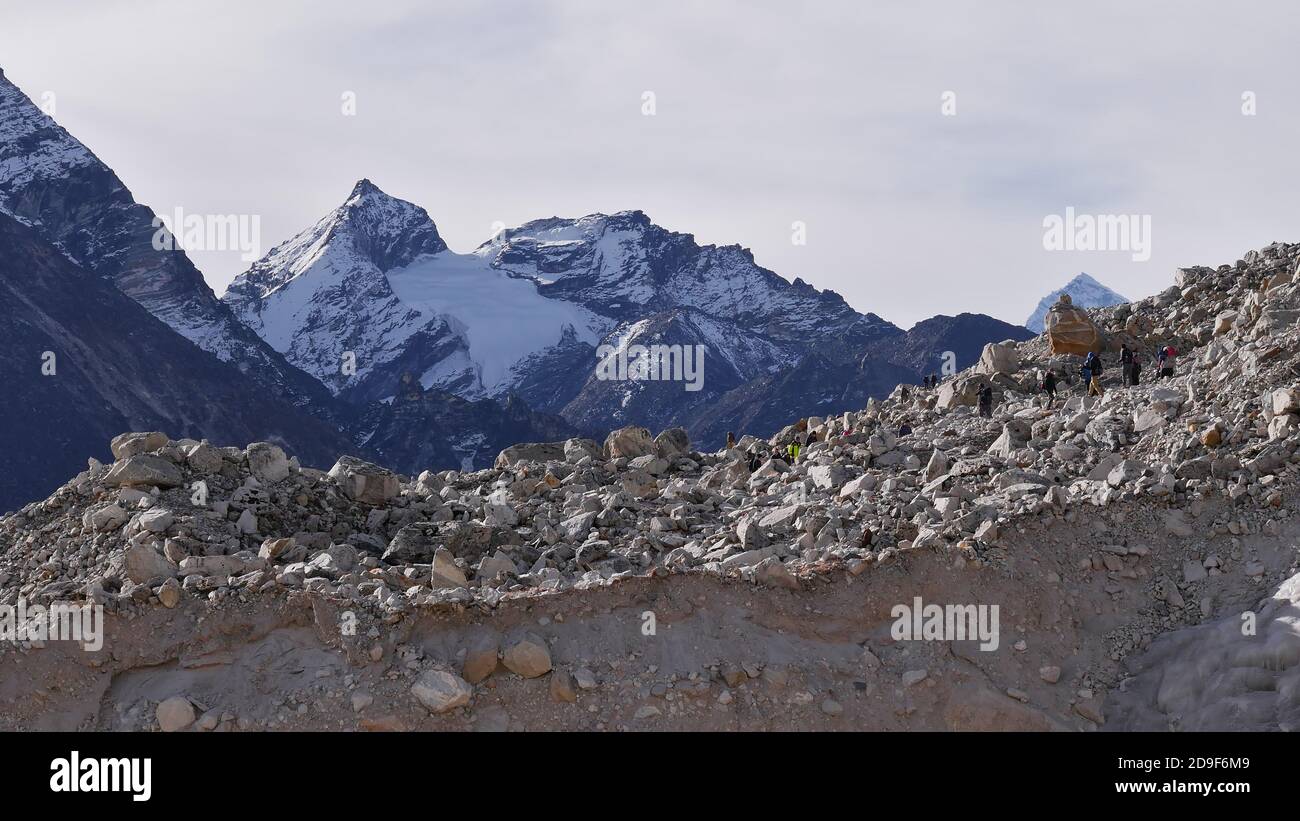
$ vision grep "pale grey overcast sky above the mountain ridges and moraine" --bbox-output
[0,0,1300,327]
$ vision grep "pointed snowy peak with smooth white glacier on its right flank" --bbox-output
[224,179,601,400]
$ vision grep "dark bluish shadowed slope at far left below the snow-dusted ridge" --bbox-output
[0,213,351,511]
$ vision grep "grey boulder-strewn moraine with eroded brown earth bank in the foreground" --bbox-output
[0,244,1300,729]
